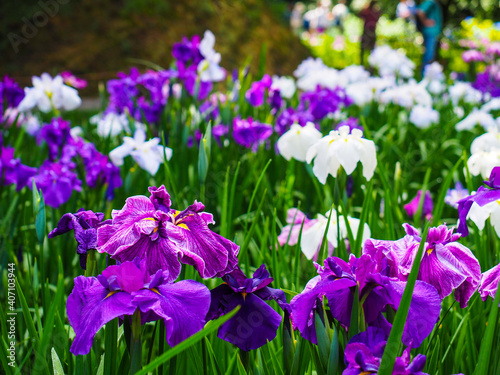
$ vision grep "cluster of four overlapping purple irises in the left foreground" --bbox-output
[49,186,289,355]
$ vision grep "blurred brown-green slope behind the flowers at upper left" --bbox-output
[0,0,309,89]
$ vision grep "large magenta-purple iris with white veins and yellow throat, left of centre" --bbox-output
[97,185,239,281]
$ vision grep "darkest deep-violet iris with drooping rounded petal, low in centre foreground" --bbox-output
[207,264,289,351]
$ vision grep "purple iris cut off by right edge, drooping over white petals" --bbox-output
[457,167,500,237]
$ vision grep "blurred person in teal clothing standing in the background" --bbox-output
[417,0,443,71]
